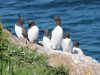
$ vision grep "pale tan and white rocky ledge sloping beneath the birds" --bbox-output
[3,29,100,75]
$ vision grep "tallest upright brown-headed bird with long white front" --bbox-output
[51,16,63,50]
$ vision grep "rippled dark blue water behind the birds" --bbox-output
[0,0,100,62]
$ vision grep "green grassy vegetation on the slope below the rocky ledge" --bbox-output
[0,24,69,75]
